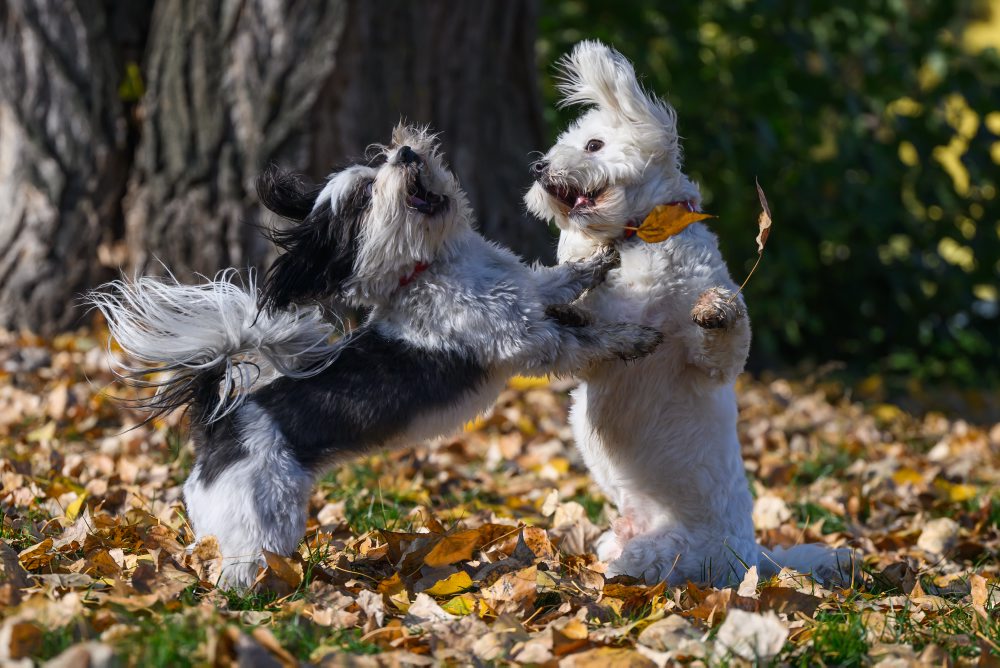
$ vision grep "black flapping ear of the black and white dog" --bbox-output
[259,180,371,311]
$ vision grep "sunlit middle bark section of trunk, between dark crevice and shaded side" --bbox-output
[126,0,346,278]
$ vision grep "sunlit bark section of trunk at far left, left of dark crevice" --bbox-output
[0,0,141,332]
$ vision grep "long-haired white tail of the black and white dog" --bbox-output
[86,269,339,423]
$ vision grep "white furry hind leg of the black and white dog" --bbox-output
[184,402,313,589]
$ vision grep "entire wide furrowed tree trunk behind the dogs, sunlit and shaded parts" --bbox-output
[0,0,554,332]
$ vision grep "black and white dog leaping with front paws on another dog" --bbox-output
[90,126,662,587]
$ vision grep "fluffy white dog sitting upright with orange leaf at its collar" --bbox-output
[525,42,852,585]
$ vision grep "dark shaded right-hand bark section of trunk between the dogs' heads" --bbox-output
[312,0,555,260]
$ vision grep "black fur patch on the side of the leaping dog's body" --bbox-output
[251,327,486,467]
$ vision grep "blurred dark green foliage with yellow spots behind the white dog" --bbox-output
[538,0,1000,385]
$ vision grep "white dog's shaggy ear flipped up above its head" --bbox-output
[558,40,677,134]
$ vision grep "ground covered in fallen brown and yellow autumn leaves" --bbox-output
[0,326,1000,666]
